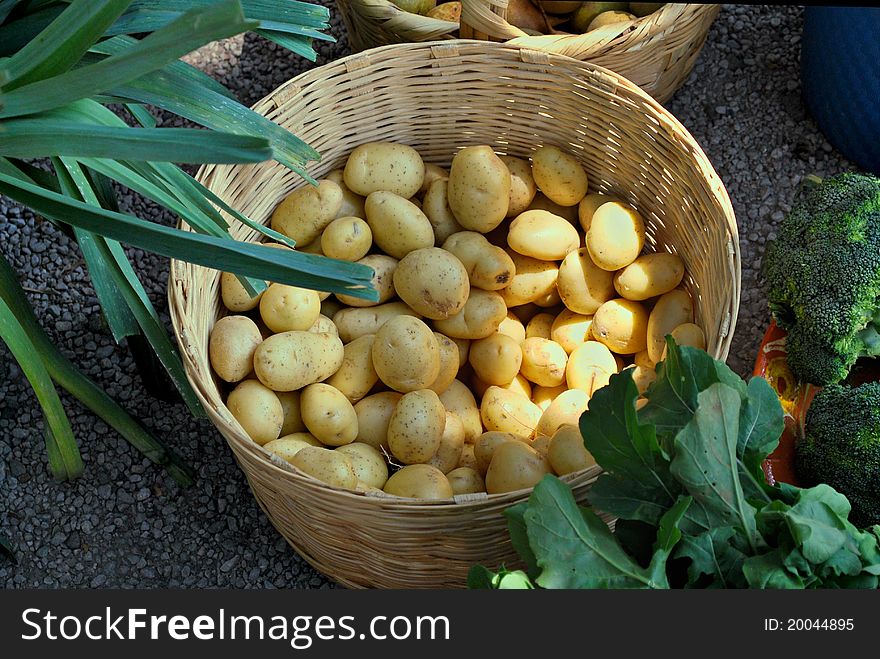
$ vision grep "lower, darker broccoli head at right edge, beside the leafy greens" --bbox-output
[795,382,880,528]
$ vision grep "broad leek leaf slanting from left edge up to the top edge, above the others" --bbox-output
[0,0,257,117]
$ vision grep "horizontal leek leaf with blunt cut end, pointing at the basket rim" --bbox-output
[0,118,273,163]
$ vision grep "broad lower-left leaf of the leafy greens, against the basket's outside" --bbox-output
[524,476,659,588]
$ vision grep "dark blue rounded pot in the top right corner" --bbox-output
[801,7,880,174]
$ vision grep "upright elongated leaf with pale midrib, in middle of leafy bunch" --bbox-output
[671,383,759,550]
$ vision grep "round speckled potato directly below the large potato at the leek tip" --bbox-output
[372,316,440,393]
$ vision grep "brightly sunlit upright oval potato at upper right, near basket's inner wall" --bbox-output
[587,201,645,272]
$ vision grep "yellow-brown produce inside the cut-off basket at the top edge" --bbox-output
[392,0,664,36]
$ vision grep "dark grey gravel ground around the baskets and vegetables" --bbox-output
[0,5,849,588]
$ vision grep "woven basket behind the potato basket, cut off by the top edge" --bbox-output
[336,0,721,103]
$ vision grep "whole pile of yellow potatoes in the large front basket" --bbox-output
[210,142,705,499]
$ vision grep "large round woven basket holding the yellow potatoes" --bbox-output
[169,41,740,588]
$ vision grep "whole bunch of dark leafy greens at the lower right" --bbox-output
[468,337,880,588]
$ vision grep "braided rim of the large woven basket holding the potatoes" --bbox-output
[168,37,741,511]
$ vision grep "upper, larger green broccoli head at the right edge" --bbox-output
[764,174,880,385]
